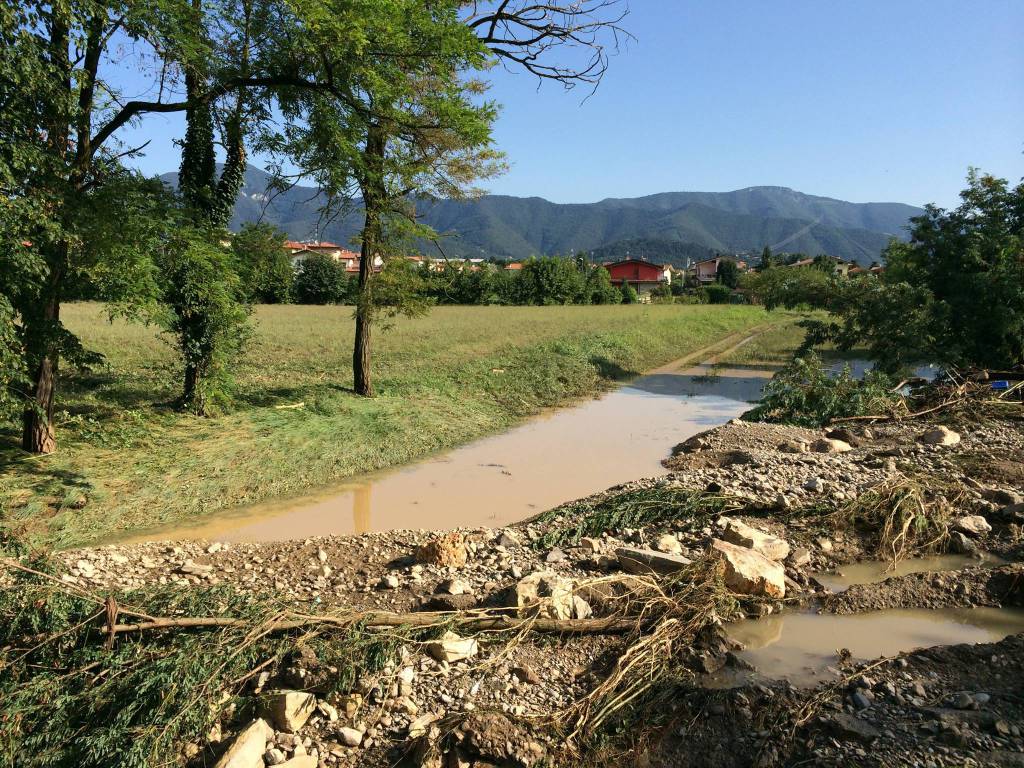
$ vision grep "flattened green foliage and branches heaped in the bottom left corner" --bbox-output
[0,562,407,768]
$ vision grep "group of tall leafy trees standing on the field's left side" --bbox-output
[0,0,626,453]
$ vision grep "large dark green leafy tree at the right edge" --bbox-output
[809,170,1024,371]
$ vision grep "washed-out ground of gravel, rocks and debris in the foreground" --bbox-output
[39,403,1024,768]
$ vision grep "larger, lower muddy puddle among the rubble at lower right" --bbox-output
[710,608,1024,686]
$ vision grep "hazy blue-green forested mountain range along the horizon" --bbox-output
[162,166,924,264]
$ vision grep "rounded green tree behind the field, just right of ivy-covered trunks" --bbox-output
[231,223,295,304]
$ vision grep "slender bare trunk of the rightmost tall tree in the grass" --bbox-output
[352,124,387,397]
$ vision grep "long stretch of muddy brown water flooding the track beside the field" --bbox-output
[125,361,772,542]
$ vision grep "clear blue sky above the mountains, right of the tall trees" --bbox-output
[117,0,1024,206]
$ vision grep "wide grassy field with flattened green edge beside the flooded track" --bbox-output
[0,304,792,547]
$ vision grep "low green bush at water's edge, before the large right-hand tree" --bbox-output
[742,354,902,427]
